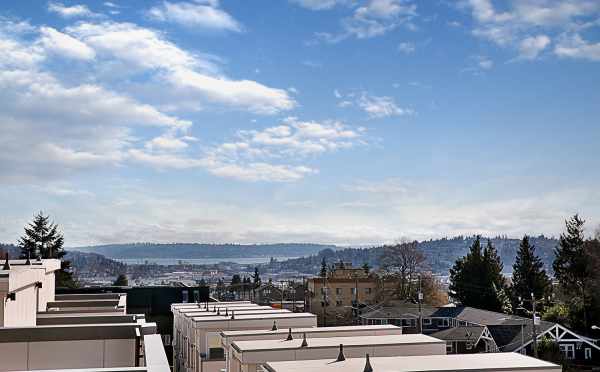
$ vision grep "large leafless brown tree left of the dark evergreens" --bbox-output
[379,241,425,299]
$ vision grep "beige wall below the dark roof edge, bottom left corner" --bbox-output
[0,339,135,371]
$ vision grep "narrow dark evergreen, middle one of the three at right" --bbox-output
[512,235,552,310]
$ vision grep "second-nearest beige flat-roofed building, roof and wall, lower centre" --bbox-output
[229,334,446,372]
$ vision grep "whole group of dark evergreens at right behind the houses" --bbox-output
[449,215,600,334]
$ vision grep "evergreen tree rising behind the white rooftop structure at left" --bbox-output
[19,212,77,288]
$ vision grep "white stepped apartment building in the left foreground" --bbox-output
[0,259,170,372]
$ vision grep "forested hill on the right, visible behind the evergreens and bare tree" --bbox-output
[271,236,558,274]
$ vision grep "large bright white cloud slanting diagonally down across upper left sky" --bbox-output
[67,22,296,114]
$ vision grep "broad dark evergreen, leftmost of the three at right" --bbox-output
[450,236,505,311]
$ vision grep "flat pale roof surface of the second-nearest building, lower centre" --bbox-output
[231,334,446,353]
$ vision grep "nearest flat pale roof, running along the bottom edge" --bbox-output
[266,353,562,372]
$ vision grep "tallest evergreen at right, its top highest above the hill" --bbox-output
[552,214,593,332]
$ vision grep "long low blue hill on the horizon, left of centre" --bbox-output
[68,243,338,259]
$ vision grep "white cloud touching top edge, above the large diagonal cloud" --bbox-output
[148,1,242,32]
